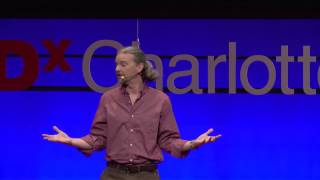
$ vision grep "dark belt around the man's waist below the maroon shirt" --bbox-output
[108,161,157,173]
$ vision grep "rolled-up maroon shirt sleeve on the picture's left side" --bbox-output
[78,95,107,156]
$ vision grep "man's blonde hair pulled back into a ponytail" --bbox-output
[118,46,159,82]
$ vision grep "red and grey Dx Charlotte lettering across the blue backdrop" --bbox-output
[0,40,320,95]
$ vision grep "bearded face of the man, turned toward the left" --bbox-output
[115,53,143,83]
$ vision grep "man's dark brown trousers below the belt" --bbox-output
[100,167,160,180]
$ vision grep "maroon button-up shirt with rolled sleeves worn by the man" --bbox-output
[79,85,188,164]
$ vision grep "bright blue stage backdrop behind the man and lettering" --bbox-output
[0,19,320,180]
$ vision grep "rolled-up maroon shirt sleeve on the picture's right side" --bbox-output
[158,96,189,158]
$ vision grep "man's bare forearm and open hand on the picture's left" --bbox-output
[42,126,92,149]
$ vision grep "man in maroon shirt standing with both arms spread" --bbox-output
[43,46,221,180]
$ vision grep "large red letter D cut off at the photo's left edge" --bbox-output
[0,40,39,90]
